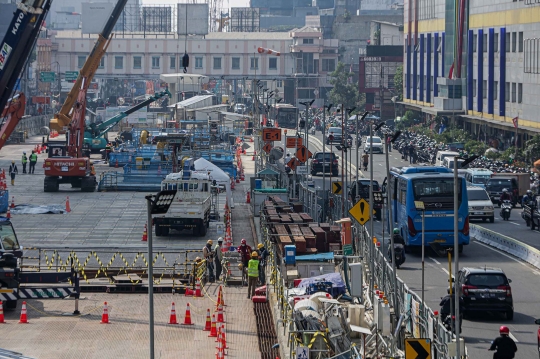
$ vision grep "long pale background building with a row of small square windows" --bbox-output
[51,27,338,104]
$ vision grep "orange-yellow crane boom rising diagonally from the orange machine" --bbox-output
[49,0,127,133]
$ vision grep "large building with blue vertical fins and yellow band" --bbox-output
[403,0,540,145]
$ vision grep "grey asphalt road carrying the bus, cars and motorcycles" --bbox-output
[304,132,540,359]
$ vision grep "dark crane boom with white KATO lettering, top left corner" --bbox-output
[0,0,52,109]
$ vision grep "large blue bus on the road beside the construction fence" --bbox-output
[388,167,470,252]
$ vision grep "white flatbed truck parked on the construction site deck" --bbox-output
[154,171,215,236]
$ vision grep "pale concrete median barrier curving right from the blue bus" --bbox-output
[470,224,540,269]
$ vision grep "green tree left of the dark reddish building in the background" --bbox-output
[328,62,365,108]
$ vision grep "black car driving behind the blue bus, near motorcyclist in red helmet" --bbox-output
[459,267,514,320]
